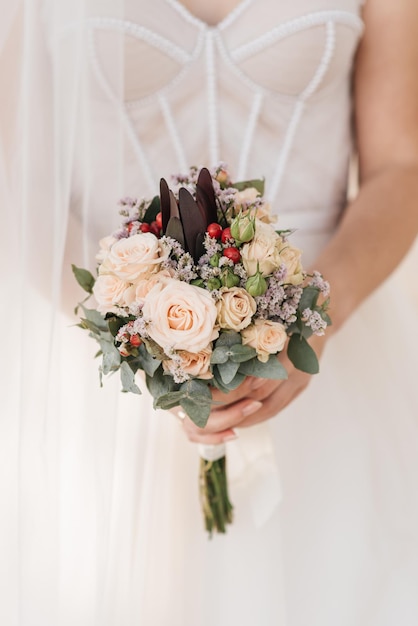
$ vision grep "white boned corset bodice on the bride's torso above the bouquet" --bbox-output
[49,0,363,258]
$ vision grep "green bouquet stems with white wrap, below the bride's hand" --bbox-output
[199,444,233,536]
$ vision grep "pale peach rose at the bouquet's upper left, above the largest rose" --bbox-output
[99,233,168,283]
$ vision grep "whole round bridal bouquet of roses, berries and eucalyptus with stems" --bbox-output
[73,165,330,534]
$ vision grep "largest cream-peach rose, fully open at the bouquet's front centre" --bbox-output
[142,278,219,353]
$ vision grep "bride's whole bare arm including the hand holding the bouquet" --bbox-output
[179,0,418,443]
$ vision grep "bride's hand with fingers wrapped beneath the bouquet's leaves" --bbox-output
[177,336,325,444]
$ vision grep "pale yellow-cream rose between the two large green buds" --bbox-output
[241,219,284,276]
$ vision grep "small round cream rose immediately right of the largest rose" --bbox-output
[216,287,257,331]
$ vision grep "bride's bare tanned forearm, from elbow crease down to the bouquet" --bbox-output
[314,163,418,336]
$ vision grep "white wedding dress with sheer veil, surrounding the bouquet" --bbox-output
[0,0,418,626]
